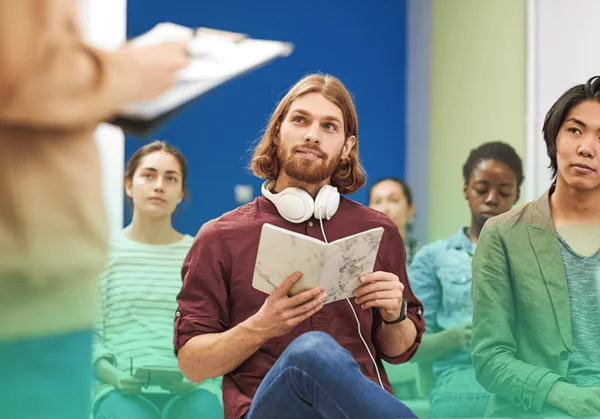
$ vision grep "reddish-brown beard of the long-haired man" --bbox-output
[277,145,342,184]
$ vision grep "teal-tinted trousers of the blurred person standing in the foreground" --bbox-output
[0,330,92,419]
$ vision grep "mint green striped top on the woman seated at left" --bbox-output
[93,231,222,408]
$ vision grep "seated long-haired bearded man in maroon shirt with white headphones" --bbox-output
[174,74,424,419]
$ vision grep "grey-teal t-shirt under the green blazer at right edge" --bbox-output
[559,236,600,387]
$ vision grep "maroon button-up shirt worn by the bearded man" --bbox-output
[174,197,425,419]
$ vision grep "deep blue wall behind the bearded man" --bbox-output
[125,0,407,234]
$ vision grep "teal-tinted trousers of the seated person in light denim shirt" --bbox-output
[429,366,490,418]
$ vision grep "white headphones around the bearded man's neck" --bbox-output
[261,180,340,223]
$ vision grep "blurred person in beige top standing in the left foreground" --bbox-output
[0,0,188,419]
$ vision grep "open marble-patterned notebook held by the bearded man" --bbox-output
[252,223,383,304]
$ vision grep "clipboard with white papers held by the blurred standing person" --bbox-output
[107,22,294,137]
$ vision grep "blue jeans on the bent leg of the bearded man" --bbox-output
[246,332,416,419]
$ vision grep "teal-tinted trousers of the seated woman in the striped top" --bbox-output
[94,389,223,419]
